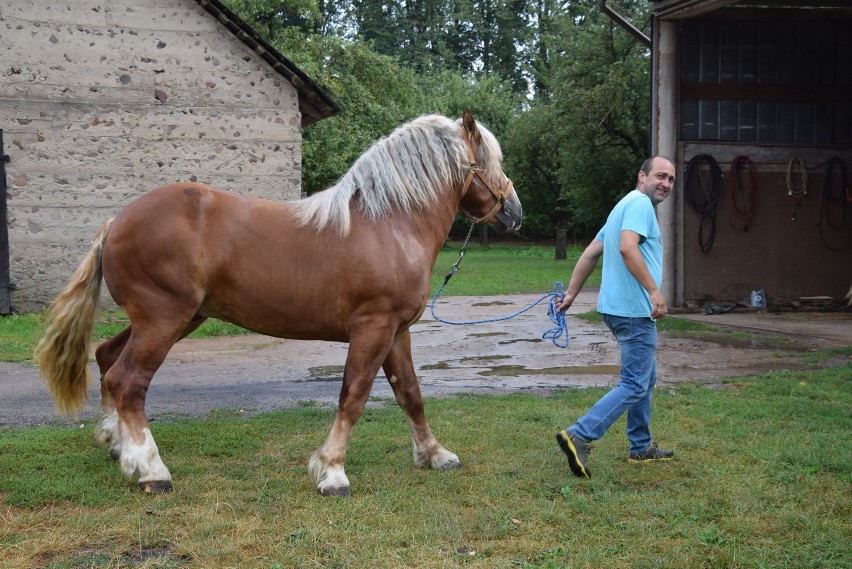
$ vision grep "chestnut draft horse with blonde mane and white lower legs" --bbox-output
[34,111,523,496]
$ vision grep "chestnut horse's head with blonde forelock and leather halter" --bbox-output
[459,110,523,231]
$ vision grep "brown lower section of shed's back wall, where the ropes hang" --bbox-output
[677,142,852,306]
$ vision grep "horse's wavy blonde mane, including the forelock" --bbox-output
[291,115,503,236]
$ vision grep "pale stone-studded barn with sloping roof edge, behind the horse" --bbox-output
[0,0,339,314]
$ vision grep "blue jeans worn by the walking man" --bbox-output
[568,314,657,453]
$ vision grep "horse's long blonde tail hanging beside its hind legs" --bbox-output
[33,219,113,416]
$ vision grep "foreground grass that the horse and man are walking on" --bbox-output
[0,365,852,569]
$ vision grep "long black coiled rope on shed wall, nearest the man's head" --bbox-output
[685,154,722,253]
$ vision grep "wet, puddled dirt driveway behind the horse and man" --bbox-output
[0,292,852,426]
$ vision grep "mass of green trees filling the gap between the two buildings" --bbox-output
[221,0,649,239]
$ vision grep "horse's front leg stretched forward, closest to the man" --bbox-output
[382,330,461,469]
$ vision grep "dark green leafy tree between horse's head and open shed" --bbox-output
[507,0,649,251]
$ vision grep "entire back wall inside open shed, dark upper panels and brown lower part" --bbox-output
[676,18,852,306]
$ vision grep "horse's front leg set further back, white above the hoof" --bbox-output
[308,325,393,496]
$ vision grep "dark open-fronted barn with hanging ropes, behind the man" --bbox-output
[620,0,852,309]
